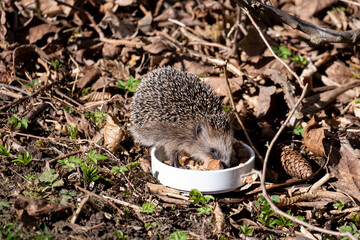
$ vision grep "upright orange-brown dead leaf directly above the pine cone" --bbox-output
[303,115,326,157]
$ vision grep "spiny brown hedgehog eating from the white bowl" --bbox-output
[130,67,233,167]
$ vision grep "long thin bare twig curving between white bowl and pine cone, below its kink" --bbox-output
[260,84,356,240]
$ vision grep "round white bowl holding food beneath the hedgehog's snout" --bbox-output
[151,144,255,194]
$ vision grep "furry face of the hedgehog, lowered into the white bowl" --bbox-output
[193,122,233,167]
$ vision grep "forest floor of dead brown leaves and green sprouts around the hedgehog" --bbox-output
[0,0,360,240]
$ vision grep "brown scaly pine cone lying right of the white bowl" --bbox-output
[280,146,313,179]
